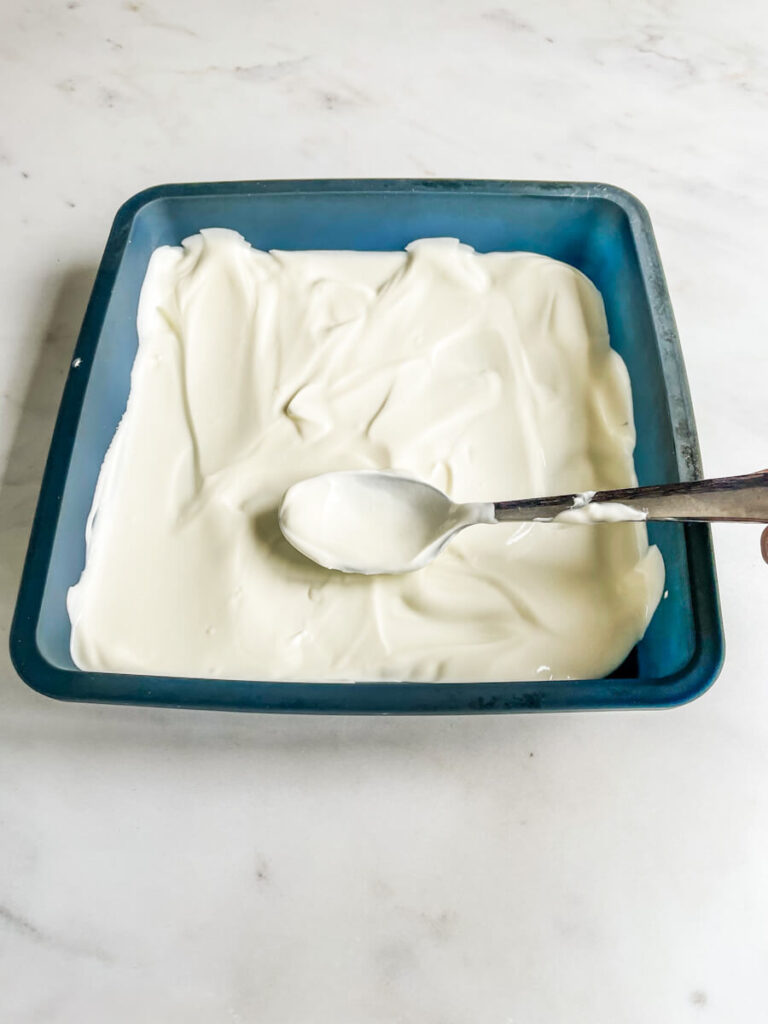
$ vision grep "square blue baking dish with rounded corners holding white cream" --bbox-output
[10,180,723,714]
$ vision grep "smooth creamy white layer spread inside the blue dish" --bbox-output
[68,228,664,681]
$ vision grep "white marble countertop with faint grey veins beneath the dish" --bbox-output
[0,0,768,1024]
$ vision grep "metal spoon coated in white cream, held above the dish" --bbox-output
[279,470,768,575]
